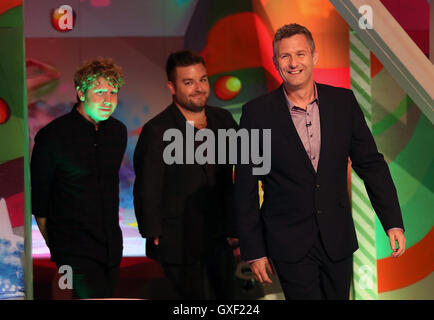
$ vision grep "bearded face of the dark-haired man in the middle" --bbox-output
[168,63,210,112]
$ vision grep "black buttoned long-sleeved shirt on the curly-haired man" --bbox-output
[31,108,127,264]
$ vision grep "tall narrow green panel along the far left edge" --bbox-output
[0,6,33,299]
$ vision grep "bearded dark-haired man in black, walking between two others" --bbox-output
[134,51,236,299]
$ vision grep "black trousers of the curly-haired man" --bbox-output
[56,257,120,299]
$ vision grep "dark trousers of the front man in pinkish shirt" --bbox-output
[273,235,353,300]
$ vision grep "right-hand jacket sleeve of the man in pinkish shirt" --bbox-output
[349,92,404,231]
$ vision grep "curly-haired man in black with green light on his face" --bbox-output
[31,58,127,299]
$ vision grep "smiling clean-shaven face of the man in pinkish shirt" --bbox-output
[273,34,318,90]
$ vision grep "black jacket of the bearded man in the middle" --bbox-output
[134,104,236,264]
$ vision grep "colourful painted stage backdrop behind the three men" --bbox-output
[0,0,434,299]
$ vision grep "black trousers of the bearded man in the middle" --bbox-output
[162,242,236,300]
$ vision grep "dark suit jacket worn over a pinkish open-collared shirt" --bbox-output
[235,84,403,262]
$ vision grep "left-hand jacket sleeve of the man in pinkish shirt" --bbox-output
[235,105,267,261]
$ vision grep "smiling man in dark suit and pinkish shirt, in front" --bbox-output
[235,24,405,299]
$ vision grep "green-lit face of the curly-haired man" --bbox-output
[77,77,118,123]
